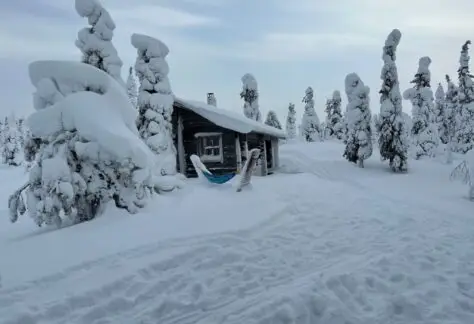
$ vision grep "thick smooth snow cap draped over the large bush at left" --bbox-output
[27,61,151,168]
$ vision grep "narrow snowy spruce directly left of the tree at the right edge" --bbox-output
[445,75,459,164]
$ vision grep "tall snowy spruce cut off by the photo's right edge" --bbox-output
[456,41,474,153]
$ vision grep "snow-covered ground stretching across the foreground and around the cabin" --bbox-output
[0,143,474,324]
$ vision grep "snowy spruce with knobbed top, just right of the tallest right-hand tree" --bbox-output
[403,56,439,159]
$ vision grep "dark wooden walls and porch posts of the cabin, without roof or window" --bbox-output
[172,105,278,177]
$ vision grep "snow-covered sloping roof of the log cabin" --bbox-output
[175,97,286,138]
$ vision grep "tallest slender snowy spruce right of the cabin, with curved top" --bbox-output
[379,29,409,172]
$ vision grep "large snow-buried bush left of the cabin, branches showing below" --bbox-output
[9,61,153,226]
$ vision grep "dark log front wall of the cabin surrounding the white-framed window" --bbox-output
[173,108,237,177]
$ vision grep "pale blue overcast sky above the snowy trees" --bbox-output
[0,0,474,120]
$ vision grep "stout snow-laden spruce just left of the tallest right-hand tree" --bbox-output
[343,73,372,168]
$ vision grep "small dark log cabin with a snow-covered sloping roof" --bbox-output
[172,98,286,178]
